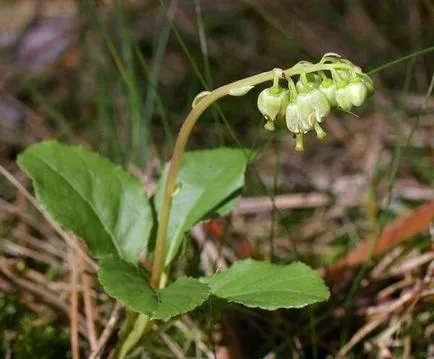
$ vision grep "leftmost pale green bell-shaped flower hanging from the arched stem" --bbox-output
[258,87,289,121]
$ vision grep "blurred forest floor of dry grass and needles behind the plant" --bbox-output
[0,0,434,358]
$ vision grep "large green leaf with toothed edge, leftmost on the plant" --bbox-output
[18,141,153,264]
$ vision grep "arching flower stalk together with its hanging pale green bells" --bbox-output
[150,54,372,289]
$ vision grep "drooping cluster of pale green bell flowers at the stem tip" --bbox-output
[258,53,374,151]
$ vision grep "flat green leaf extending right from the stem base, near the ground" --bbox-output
[201,259,330,310]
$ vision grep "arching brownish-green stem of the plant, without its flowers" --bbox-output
[151,63,352,289]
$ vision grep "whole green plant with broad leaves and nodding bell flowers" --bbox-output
[18,54,373,358]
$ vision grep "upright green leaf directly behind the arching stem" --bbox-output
[155,148,248,265]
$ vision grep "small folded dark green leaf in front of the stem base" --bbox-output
[98,258,210,319]
